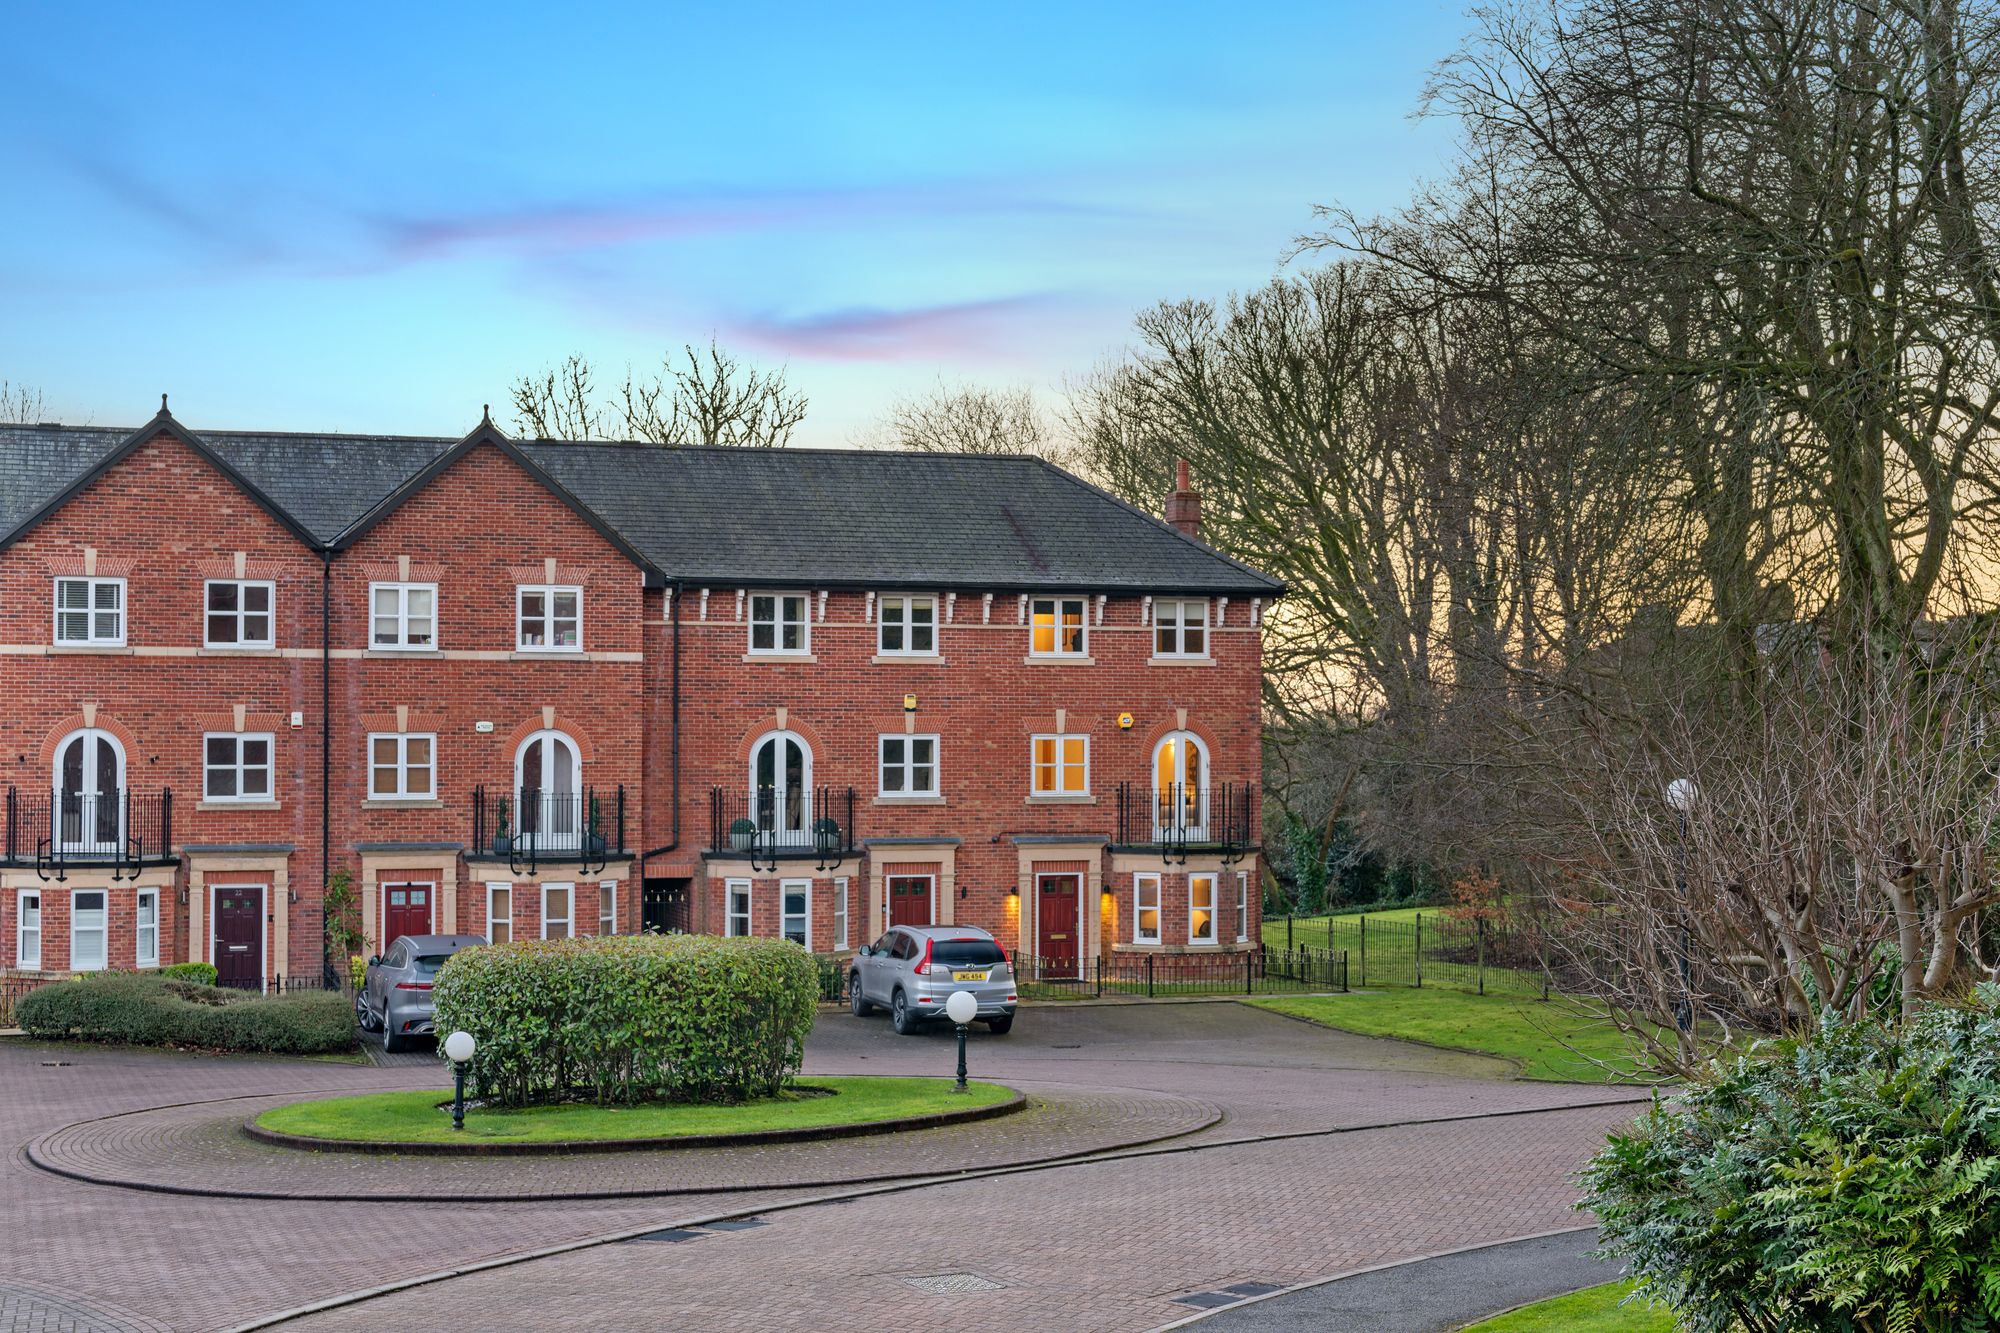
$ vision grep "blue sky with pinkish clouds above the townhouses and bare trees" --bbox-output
[0,0,1464,444]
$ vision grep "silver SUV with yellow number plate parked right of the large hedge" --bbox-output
[848,927,1020,1037]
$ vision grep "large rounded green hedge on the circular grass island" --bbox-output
[432,935,820,1107]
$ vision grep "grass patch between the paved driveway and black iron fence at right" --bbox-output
[1246,987,1634,1083]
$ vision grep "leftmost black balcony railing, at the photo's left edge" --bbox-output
[0,787,174,881]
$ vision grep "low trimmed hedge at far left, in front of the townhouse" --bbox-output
[14,973,354,1055]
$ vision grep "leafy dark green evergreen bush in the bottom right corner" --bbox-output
[1584,987,2000,1333]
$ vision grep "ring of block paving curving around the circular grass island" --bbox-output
[28,1087,1222,1203]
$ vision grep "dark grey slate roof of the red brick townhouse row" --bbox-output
[0,426,1282,596]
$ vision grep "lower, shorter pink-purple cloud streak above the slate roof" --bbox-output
[730,292,1062,360]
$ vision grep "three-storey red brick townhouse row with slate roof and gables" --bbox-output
[0,402,1282,987]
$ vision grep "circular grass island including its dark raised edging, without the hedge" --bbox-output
[244,1077,1026,1153]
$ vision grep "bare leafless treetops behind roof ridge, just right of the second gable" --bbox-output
[510,340,806,448]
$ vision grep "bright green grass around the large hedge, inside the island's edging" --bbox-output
[258,1079,1014,1143]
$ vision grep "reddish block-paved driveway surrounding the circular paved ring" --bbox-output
[0,1005,1634,1329]
